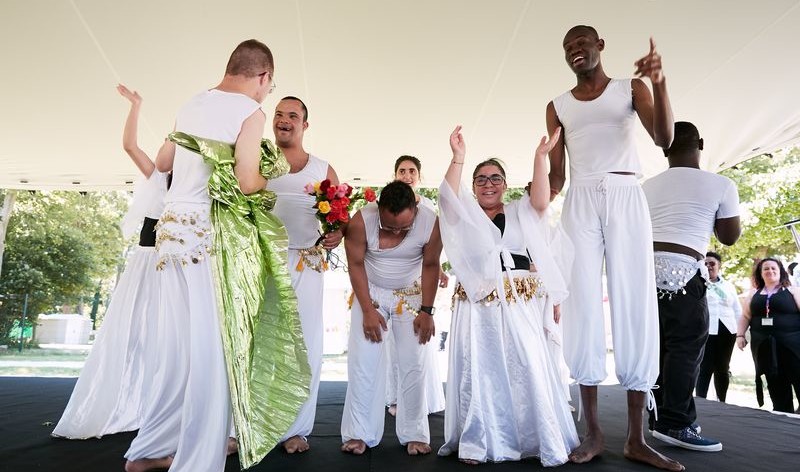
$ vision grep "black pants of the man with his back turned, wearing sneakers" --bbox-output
[650,271,708,430]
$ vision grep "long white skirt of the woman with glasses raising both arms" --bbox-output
[439,278,578,466]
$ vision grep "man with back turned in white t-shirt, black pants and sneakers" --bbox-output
[643,121,741,452]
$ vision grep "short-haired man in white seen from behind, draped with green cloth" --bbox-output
[125,40,274,472]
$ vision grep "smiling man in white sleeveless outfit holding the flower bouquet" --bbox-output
[267,97,342,454]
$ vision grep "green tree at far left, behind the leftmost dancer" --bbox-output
[0,192,127,342]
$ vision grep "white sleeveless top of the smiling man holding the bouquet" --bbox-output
[267,154,328,249]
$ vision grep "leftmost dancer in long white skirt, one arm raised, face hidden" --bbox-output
[52,85,167,439]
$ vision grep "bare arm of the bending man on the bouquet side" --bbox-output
[344,211,388,343]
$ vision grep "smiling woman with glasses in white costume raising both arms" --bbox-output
[439,126,578,466]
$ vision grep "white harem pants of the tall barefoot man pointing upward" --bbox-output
[561,174,659,392]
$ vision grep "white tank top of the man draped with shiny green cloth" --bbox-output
[164,89,261,204]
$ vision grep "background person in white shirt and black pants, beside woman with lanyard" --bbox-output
[695,252,742,403]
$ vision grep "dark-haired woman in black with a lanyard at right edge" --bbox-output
[736,257,800,413]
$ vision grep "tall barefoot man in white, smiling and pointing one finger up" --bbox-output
[546,25,683,470]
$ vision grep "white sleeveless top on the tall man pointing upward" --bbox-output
[553,79,642,179]
